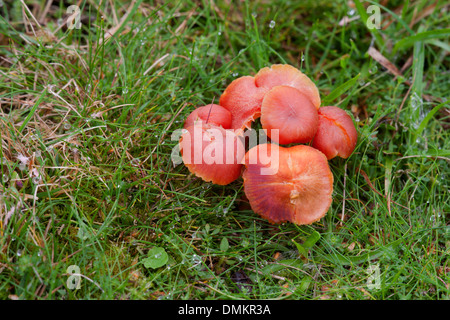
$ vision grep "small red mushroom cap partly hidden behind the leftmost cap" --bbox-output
[184,103,231,129]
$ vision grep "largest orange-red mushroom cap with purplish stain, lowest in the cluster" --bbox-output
[242,144,333,225]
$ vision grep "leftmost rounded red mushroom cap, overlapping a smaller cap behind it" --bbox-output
[179,122,245,185]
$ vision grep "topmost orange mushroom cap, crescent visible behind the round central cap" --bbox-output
[255,64,320,109]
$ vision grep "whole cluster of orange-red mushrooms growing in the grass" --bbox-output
[179,64,357,225]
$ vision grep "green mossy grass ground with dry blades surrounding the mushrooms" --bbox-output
[0,0,450,299]
